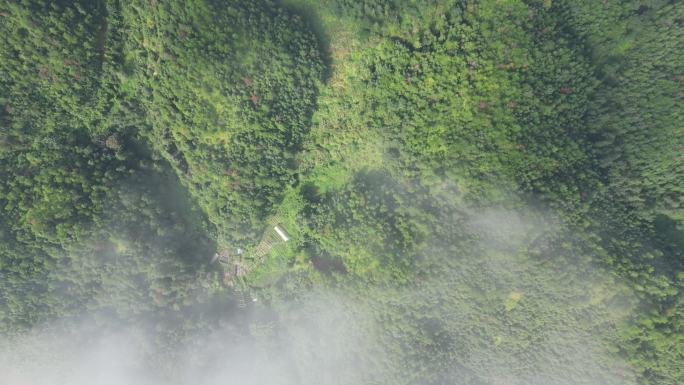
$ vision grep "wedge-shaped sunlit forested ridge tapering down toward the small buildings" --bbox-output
[121,2,322,242]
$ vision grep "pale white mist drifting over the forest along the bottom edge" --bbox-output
[0,208,634,385]
